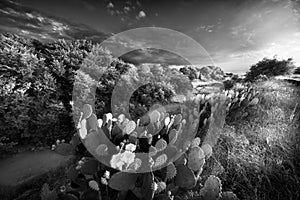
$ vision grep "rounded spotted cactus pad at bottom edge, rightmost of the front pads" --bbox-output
[200,175,222,200]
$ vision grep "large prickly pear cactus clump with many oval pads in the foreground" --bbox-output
[41,88,239,200]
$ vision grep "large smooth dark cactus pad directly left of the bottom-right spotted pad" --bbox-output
[175,164,196,189]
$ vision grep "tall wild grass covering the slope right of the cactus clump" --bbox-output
[214,80,300,200]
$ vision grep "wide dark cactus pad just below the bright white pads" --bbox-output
[108,172,138,191]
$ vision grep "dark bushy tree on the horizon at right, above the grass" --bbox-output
[245,57,295,81]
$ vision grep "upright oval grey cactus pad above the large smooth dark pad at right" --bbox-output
[188,146,205,171]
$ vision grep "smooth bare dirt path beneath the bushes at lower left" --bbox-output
[0,150,72,186]
